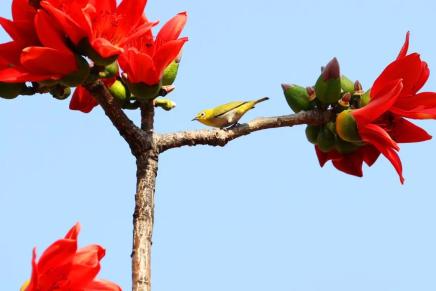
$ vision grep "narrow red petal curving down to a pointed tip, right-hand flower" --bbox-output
[359,124,404,184]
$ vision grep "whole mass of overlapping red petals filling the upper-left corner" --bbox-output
[0,0,187,112]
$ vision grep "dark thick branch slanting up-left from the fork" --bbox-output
[85,81,146,156]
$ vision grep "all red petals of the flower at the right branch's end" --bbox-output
[316,33,436,183]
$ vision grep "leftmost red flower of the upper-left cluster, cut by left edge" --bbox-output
[0,0,79,83]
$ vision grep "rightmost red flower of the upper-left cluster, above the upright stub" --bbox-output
[119,12,188,86]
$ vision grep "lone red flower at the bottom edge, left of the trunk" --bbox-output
[21,224,121,291]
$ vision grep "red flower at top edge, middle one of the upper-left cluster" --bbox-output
[41,0,155,62]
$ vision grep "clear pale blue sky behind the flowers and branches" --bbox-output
[0,0,436,291]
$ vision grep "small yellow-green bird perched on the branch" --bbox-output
[193,97,269,128]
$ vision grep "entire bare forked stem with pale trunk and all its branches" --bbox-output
[85,81,331,291]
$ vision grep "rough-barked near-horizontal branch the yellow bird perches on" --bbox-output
[157,110,331,152]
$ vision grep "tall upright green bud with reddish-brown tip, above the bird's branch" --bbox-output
[315,58,341,104]
